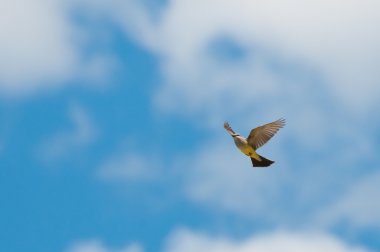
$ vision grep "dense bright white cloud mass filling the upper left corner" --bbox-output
[0,0,77,93]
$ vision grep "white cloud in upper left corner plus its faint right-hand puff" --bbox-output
[0,0,115,97]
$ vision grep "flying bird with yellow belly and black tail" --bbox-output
[224,118,286,167]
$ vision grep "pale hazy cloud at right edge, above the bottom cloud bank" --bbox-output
[317,172,380,230]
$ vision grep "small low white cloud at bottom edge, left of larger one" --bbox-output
[66,240,144,252]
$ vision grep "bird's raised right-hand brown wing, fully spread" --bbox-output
[247,118,285,150]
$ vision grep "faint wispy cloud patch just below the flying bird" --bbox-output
[184,139,289,218]
